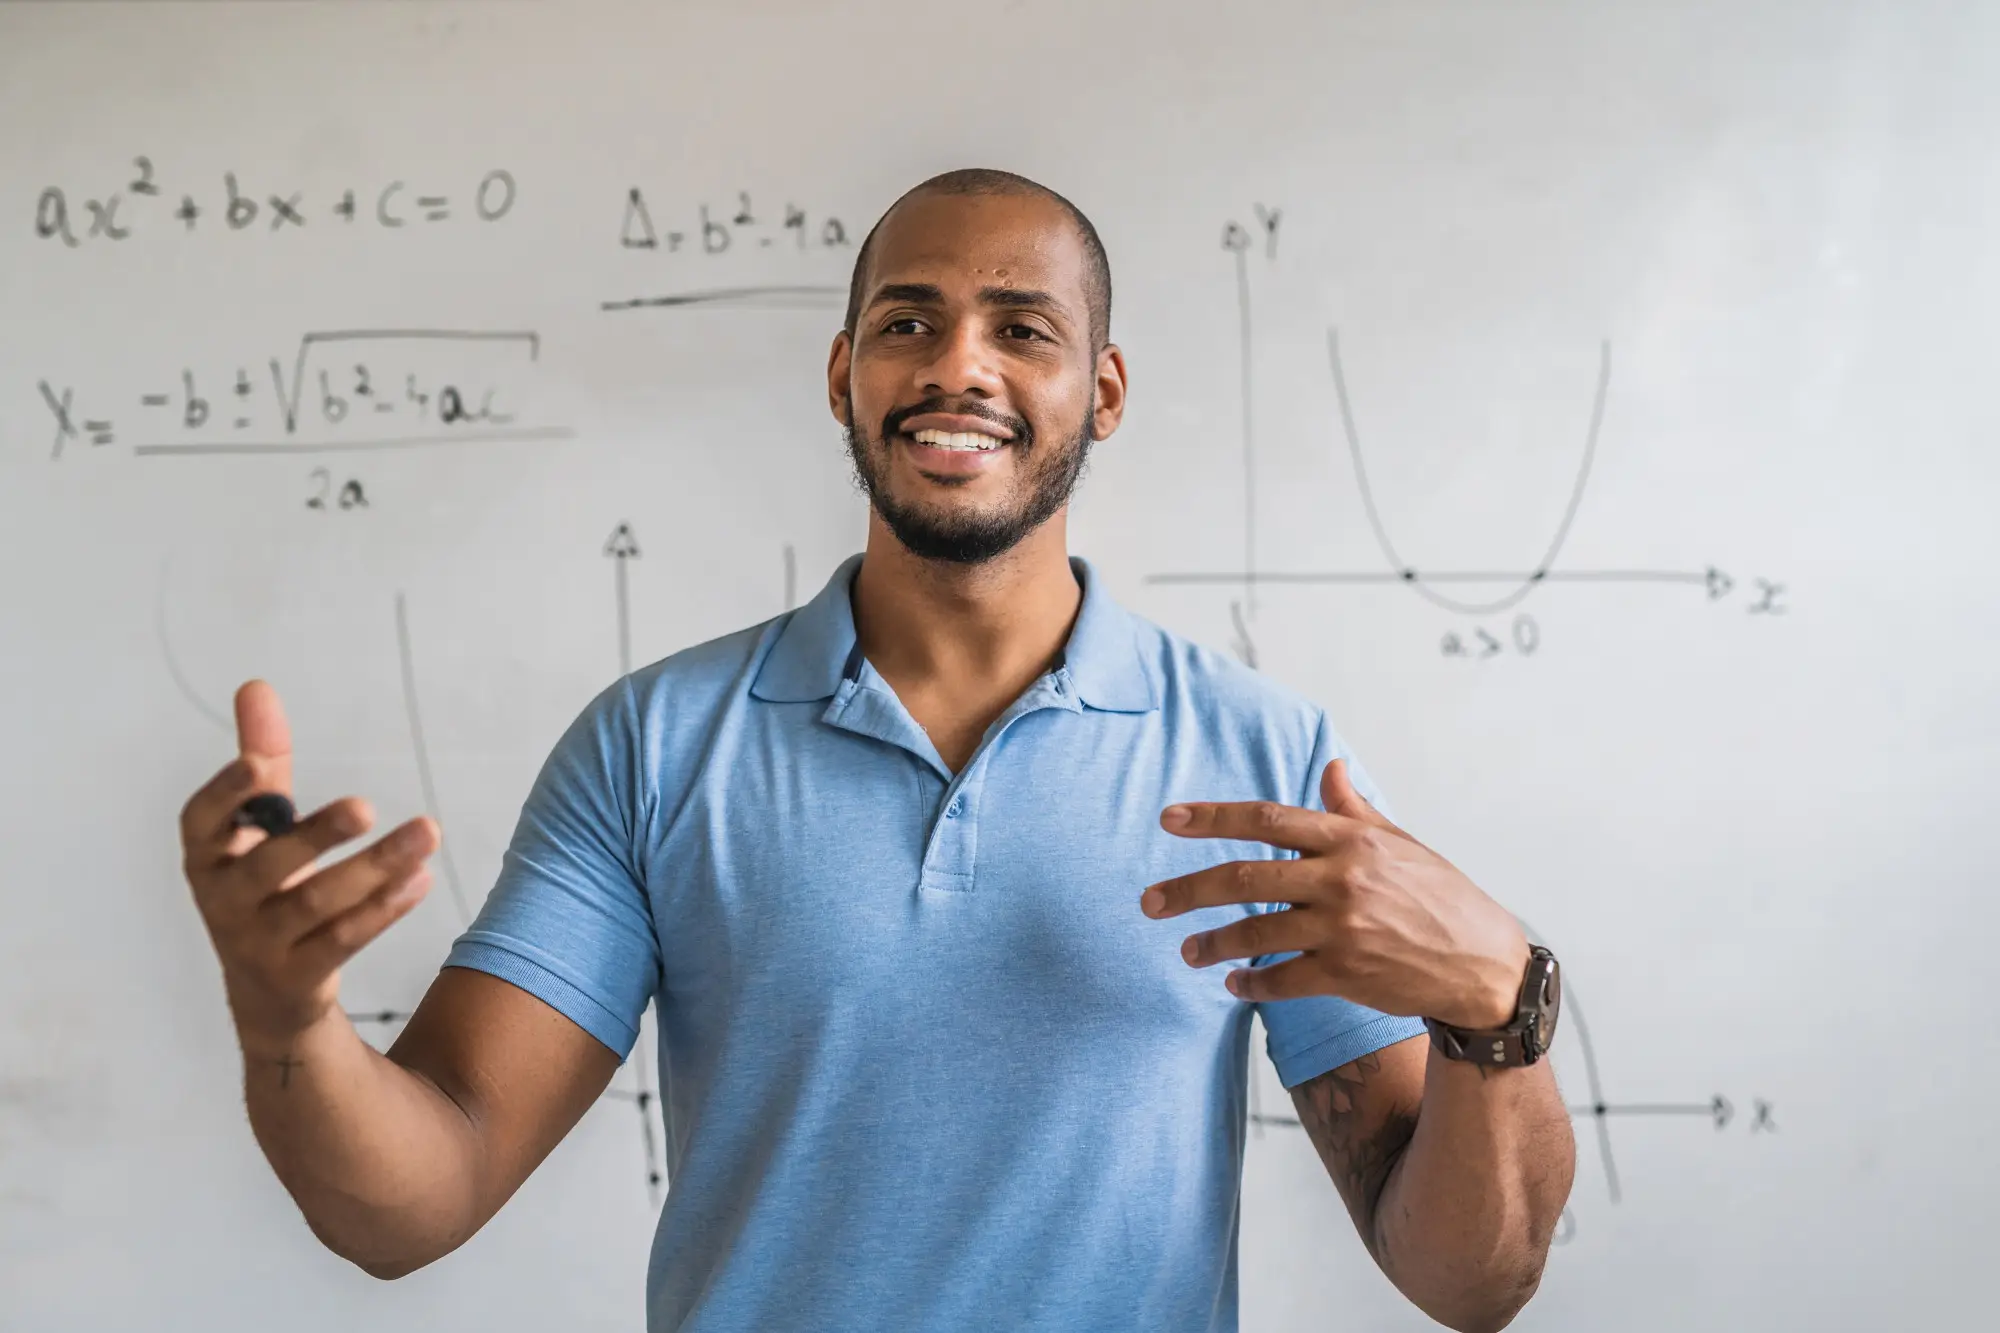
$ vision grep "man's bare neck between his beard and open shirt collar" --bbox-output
[854,512,1082,707]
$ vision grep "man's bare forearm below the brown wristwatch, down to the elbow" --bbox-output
[1372,1051,1576,1331]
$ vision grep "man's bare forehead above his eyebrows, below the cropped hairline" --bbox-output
[868,192,1084,302]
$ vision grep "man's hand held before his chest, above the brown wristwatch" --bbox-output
[1140,759,1528,1029]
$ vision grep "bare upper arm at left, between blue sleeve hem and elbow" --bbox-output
[388,967,620,1241]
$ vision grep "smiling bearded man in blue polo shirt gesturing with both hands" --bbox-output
[182,172,1574,1333]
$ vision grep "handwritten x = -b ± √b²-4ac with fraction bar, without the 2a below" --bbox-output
[36,328,570,460]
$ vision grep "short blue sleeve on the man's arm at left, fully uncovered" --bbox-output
[444,681,660,1059]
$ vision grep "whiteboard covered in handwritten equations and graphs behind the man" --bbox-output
[0,0,2000,1333]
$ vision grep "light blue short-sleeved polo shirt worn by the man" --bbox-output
[446,556,1422,1333]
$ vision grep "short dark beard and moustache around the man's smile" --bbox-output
[842,398,1096,564]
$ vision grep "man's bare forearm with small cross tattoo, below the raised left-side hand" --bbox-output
[238,1009,476,1277]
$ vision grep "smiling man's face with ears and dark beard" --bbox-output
[828,194,1124,564]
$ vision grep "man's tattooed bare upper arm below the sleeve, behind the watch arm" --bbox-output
[1292,1037,1430,1263]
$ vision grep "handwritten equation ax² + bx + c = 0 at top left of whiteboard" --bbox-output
[34,156,520,250]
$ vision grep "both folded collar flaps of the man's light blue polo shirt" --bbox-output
[750,554,1160,713]
